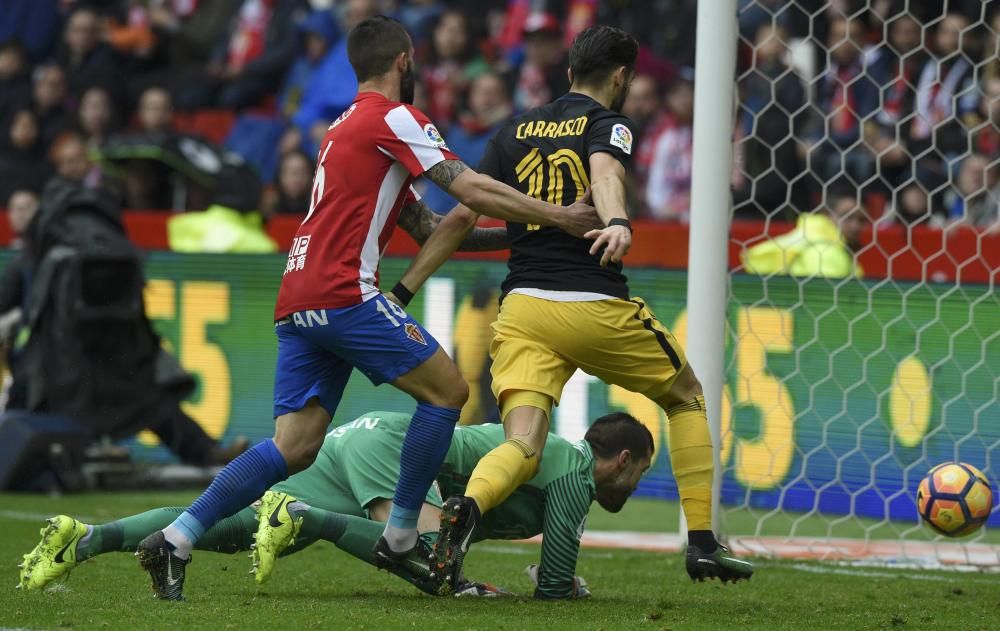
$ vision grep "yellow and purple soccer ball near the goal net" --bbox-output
[917,462,993,537]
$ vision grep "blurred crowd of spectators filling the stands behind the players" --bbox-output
[0,0,1000,229]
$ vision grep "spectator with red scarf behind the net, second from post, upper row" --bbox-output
[808,16,879,187]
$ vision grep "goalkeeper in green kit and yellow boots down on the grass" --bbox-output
[18,412,653,599]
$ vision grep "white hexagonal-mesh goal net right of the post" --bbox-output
[716,0,1000,567]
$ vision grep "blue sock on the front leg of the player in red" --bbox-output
[386,403,462,549]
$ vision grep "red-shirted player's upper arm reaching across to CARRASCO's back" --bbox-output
[424,160,604,237]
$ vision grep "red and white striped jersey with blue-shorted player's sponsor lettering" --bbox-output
[274,92,458,320]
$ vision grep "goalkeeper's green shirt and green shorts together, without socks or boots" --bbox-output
[275,412,596,598]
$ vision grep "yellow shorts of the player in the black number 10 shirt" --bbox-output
[490,294,687,404]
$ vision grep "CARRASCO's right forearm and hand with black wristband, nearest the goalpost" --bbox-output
[584,151,632,265]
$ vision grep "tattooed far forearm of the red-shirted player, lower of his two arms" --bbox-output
[399,200,510,254]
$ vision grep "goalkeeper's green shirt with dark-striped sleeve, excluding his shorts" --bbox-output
[438,425,596,598]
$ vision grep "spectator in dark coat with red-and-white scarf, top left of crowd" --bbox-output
[177,0,305,110]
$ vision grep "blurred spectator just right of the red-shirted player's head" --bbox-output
[420,11,485,131]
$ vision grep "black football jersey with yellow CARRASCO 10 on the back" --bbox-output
[479,92,633,300]
